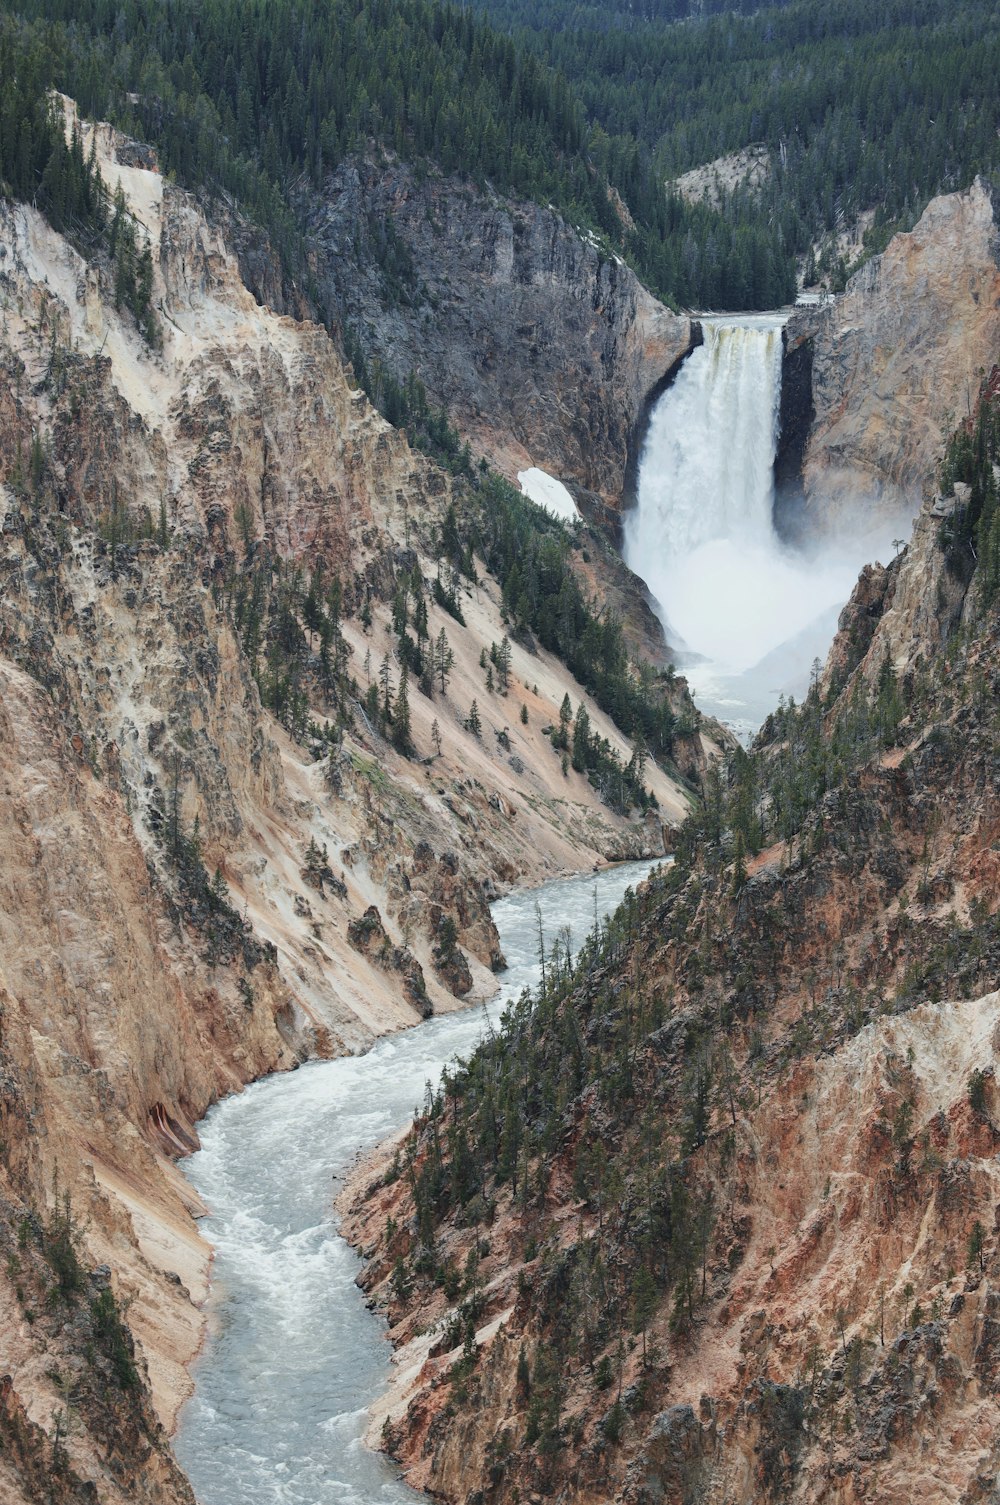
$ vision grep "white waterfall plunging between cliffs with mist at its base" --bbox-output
[623,313,893,734]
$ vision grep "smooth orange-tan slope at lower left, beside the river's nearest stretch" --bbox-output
[0,658,301,1505]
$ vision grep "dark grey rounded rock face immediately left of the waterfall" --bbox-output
[309,158,691,506]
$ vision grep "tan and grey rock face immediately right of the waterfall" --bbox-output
[786,179,1000,533]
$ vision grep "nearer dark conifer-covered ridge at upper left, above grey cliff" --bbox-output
[5,0,671,294]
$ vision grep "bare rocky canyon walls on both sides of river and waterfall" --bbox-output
[0,88,1000,1505]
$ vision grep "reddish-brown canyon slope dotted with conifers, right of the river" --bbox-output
[349,385,1000,1505]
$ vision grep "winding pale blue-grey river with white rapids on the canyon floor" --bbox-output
[175,862,655,1505]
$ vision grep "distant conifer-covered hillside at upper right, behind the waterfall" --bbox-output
[472,0,1000,296]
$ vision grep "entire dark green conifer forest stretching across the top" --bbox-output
[0,0,1000,307]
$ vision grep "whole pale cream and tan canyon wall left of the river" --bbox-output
[0,102,705,1505]
